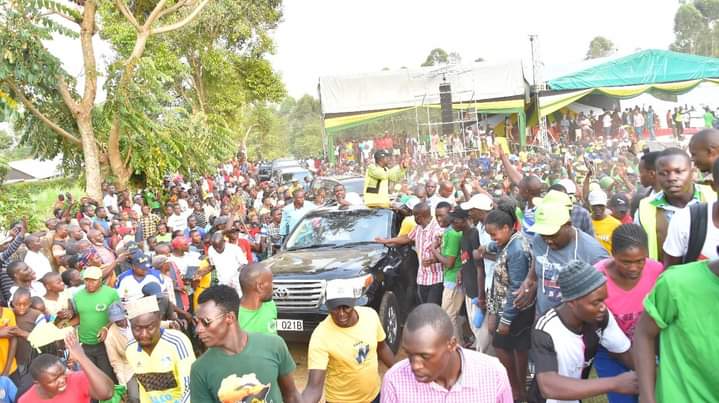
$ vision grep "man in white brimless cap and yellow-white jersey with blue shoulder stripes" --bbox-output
[125,296,195,402]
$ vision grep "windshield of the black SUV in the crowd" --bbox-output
[286,210,390,250]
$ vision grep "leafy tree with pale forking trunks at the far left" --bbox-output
[0,0,209,199]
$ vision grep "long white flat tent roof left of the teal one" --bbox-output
[319,60,526,117]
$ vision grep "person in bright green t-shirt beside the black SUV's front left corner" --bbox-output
[237,263,277,334]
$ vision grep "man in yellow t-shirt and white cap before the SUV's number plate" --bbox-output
[302,284,394,403]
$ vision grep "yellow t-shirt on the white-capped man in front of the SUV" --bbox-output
[307,306,386,402]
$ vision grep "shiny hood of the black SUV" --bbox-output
[262,245,386,280]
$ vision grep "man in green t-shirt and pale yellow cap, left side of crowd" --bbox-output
[72,267,120,382]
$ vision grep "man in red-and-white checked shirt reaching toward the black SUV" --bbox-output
[375,203,444,305]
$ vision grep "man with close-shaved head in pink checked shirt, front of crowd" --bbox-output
[380,304,514,403]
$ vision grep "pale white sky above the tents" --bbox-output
[270,0,679,97]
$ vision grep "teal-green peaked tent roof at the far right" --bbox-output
[548,49,719,90]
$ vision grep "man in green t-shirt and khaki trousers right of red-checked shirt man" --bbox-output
[434,203,467,340]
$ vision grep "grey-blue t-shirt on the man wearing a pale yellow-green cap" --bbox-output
[532,228,609,315]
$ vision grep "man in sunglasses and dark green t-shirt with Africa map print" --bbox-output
[190,285,301,403]
